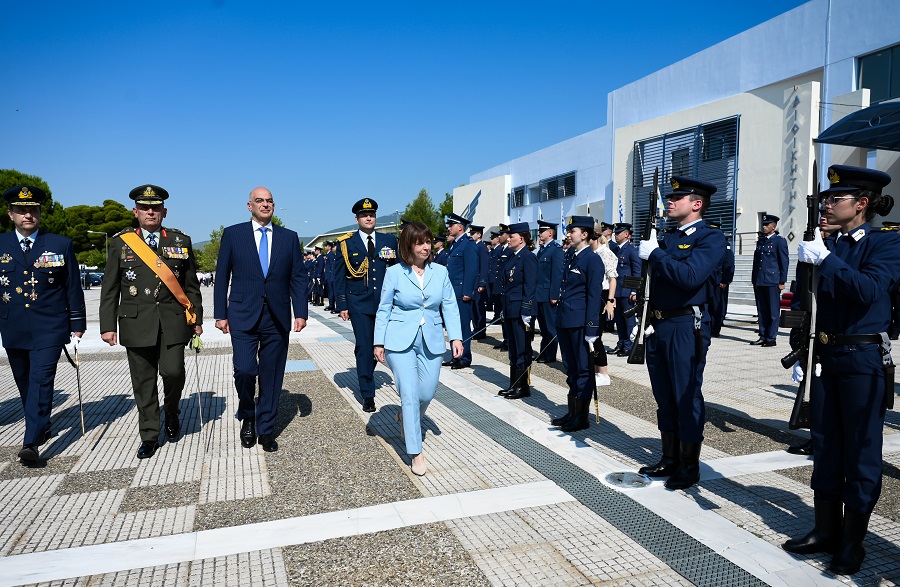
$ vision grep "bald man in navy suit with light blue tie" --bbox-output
[214,187,308,452]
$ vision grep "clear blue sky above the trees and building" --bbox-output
[0,0,802,241]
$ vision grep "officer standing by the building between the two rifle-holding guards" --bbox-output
[750,214,790,346]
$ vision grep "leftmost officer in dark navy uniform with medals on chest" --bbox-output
[0,185,87,465]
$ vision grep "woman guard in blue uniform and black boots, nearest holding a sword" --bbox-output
[550,216,605,432]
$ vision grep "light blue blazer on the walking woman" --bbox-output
[375,263,462,355]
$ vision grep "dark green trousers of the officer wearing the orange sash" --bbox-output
[126,328,185,442]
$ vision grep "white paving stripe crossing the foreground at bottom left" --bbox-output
[0,481,574,586]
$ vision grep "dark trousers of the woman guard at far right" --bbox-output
[810,344,885,514]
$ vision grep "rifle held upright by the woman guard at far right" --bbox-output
[779,162,819,430]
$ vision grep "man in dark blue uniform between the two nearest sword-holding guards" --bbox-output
[534,220,565,363]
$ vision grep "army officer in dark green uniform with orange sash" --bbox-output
[100,185,203,459]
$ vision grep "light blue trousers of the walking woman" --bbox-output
[384,327,442,455]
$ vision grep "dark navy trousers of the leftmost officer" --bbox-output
[6,346,62,444]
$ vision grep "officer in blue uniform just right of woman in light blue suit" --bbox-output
[443,213,478,369]
